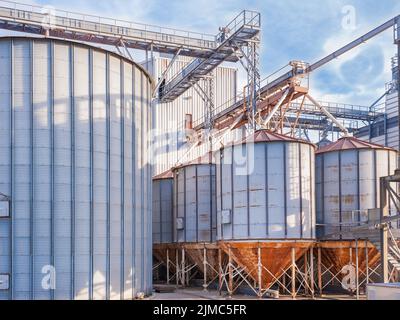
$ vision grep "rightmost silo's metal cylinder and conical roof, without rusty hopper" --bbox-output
[316,137,397,239]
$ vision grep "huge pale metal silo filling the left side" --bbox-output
[0,37,152,299]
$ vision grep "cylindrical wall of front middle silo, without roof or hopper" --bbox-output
[217,140,316,240]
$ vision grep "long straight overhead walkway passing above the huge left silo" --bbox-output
[0,0,225,61]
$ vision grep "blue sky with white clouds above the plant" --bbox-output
[3,0,400,106]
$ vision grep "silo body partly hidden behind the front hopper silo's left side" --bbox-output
[174,155,217,243]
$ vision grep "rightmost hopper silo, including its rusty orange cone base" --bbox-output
[316,137,397,286]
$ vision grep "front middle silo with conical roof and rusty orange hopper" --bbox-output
[216,130,315,296]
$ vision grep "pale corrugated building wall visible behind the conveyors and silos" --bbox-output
[148,58,237,175]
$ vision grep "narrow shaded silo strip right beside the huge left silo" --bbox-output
[153,171,174,244]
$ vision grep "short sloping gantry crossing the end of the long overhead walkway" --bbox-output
[159,10,261,102]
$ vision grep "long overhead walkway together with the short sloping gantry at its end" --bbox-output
[0,0,261,102]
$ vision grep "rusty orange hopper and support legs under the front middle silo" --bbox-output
[219,241,315,299]
